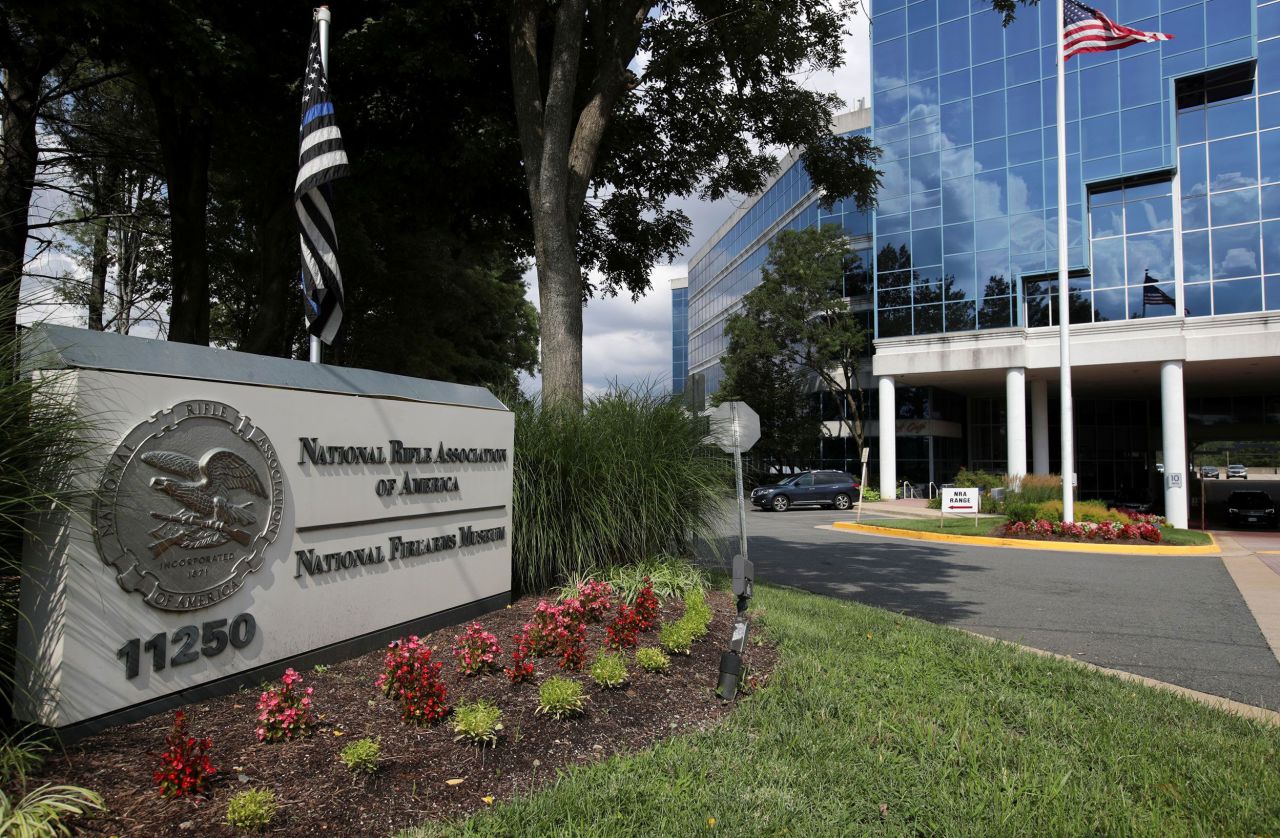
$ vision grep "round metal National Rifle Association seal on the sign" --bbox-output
[93,399,284,612]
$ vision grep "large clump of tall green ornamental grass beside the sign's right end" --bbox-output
[512,390,733,591]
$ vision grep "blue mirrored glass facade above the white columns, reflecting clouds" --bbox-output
[872,0,1280,338]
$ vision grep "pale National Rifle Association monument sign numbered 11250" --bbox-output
[17,328,515,729]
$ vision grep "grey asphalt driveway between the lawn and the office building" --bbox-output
[732,510,1280,709]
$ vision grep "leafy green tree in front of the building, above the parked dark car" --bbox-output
[724,228,867,450]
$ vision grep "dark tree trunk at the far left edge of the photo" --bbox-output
[0,61,52,335]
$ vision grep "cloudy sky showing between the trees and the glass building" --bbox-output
[521,13,870,395]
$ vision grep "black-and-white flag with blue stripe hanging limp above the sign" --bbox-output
[293,10,347,343]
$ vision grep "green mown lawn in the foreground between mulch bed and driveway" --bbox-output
[411,585,1280,837]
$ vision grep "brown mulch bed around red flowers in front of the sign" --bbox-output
[40,592,777,837]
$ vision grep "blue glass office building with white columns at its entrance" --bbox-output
[690,0,1280,522]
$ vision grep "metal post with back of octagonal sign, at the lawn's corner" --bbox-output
[705,402,760,701]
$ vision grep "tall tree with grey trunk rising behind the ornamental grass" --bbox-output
[507,0,878,406]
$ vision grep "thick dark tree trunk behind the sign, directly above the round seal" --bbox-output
[147,81,212,347]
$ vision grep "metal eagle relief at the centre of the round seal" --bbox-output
[142,448,268,557]
